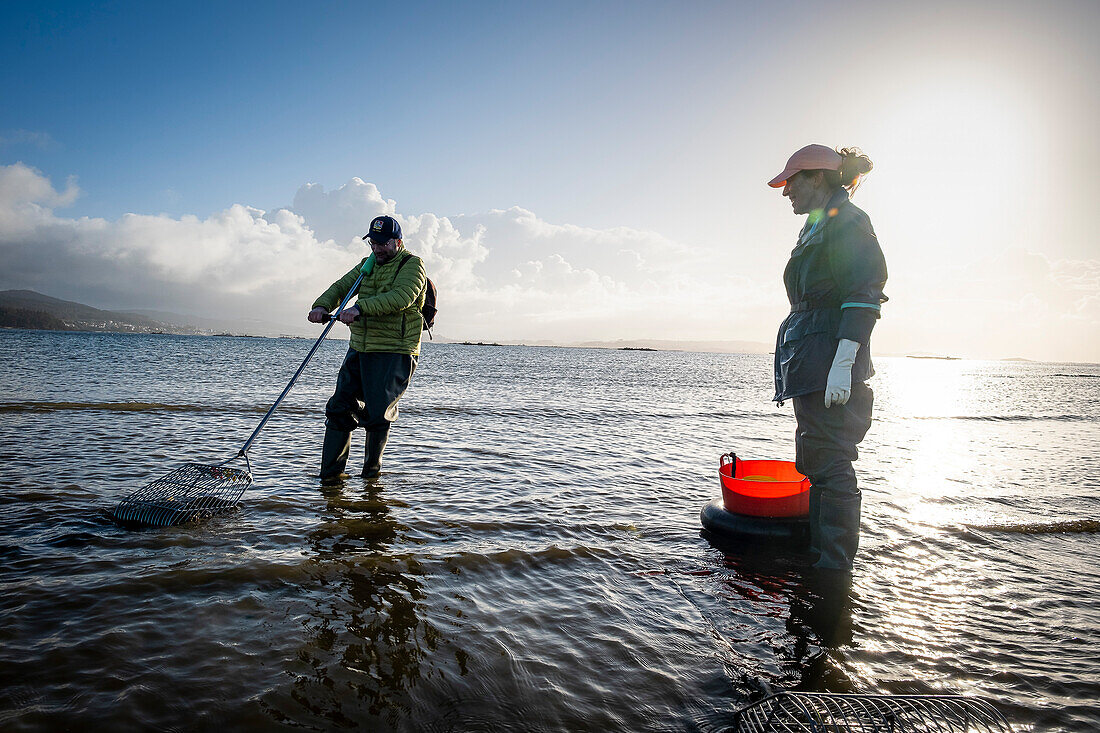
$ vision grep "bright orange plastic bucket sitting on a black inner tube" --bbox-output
[718,453,810,516]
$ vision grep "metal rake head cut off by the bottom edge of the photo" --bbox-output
[733,692,1012,733]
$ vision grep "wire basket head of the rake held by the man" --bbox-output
[110,457,252,527]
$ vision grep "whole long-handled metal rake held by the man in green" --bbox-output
[108,268,363,527]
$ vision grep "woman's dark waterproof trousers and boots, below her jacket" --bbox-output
[792,382,875,570]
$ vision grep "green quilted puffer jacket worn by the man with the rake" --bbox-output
[314,250,428,357]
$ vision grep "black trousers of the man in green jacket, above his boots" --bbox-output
[325,349,417,433]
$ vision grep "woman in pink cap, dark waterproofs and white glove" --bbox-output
[768,145,887,570]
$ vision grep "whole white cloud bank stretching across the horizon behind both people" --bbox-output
[0,163,1100,360]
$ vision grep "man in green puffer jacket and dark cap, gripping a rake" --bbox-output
[308,217,427,479]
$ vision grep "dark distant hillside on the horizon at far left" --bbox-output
[0,291,197,333]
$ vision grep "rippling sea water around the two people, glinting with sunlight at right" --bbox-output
[0,330,1100,731]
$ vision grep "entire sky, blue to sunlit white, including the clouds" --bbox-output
[0,0,1100,362]
